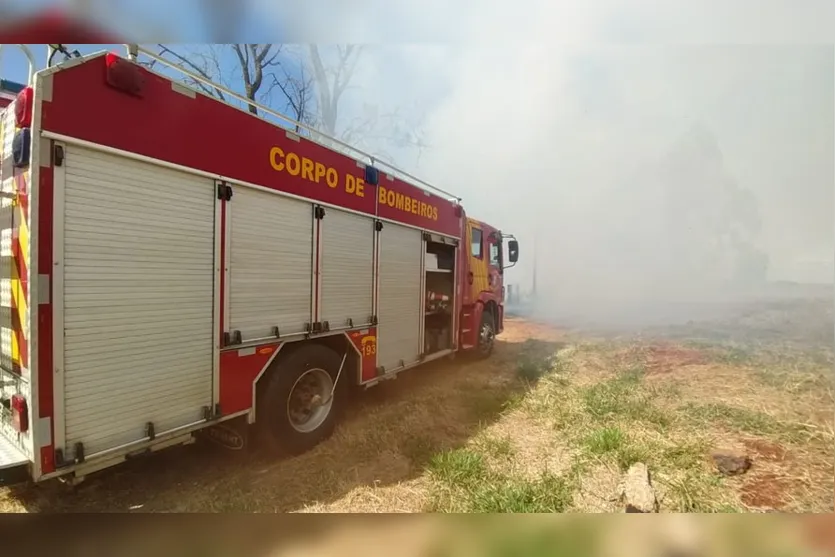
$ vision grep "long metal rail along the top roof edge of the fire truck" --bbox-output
[124,44,461,202]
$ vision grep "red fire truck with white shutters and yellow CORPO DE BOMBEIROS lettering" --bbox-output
[0,45,518,482]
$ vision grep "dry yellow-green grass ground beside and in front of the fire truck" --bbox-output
[0,308,835,512]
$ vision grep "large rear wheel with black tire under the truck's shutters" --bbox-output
[256,344,350,456]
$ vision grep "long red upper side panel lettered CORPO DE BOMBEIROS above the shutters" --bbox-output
[42,57,460,236]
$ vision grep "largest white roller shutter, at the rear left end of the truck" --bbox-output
[63,146,217,456]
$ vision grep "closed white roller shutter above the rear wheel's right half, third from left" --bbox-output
[319,208,374,330]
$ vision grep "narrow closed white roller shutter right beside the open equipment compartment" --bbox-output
[377,222,423,372]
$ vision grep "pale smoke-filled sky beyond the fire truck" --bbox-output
[0,0,835,326]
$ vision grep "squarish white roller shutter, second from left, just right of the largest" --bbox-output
[228,186,313,342]
